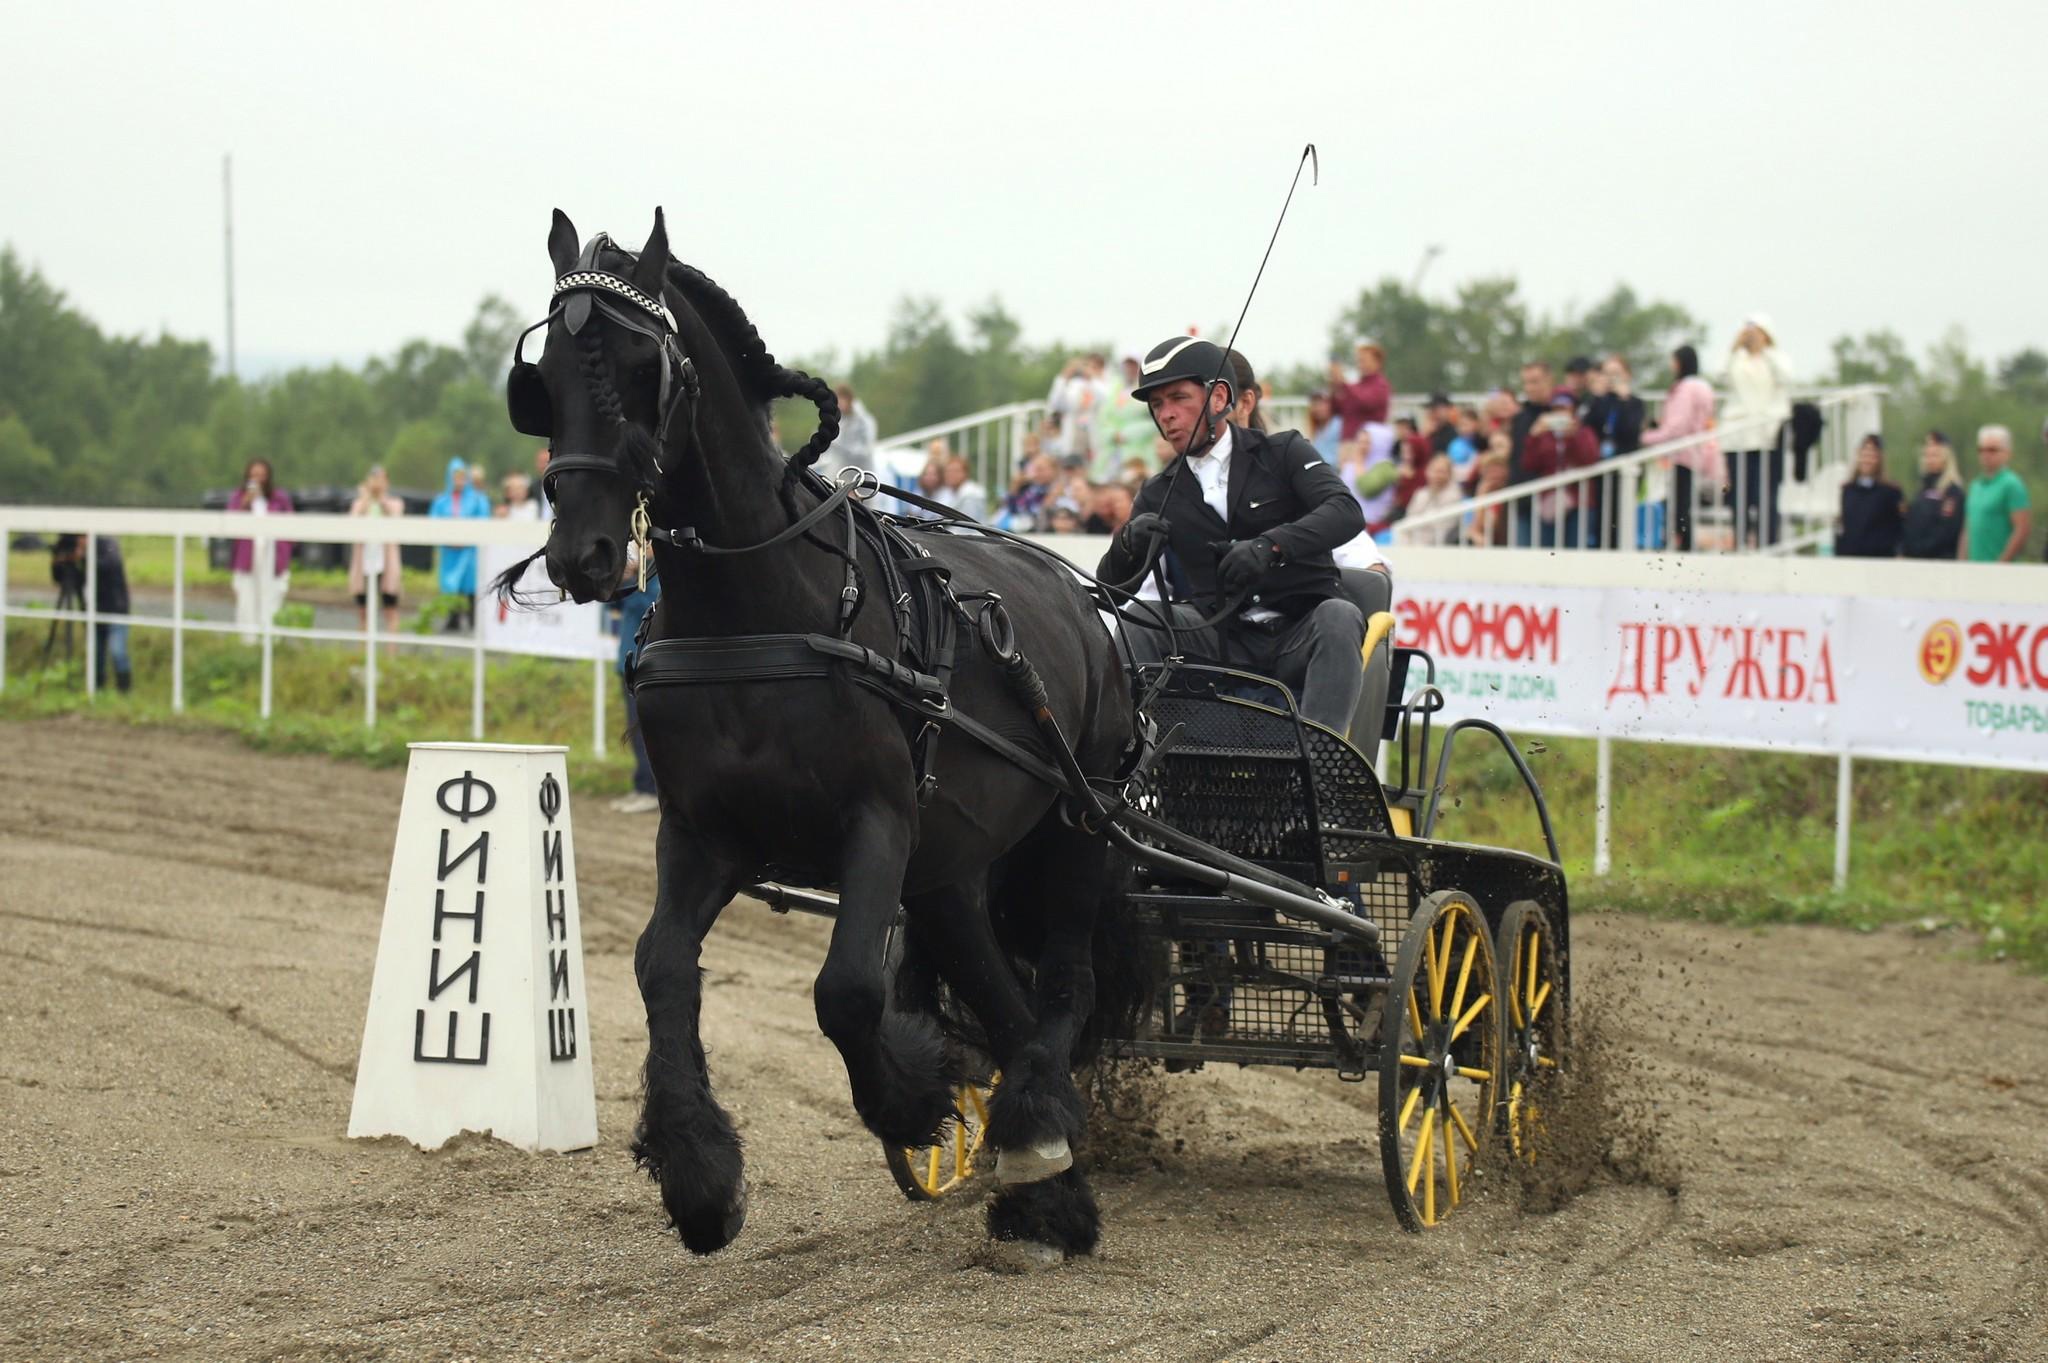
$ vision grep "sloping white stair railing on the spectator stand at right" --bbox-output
[1393,387,1884,555]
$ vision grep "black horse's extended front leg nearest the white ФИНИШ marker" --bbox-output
[633,812,748,1255]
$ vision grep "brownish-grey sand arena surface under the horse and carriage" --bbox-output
[0,720,2048,1363]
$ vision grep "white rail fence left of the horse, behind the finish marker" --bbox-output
[0,505,614,757]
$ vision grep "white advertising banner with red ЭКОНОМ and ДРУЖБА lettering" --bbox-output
[1395,581,2048,772]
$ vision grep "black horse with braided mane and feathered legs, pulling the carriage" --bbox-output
[508,211,1135,1255]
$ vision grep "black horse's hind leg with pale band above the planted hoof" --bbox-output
[989,825,1108,1255]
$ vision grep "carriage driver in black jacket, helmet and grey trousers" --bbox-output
[1096,336,1366,733]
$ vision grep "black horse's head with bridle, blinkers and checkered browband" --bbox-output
[506,209,696,602]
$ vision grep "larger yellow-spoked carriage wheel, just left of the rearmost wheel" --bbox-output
[1380,890,1501,1230]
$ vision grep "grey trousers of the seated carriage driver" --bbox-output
[1124,598,1366,733]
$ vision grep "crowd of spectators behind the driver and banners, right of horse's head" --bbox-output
[831,323,2048,563]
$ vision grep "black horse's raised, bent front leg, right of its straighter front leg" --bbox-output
[815,808,958,1146]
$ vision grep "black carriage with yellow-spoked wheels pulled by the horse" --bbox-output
[754,571,1569,1230]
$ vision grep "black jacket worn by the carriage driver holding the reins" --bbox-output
[1096,426,1366,614]
